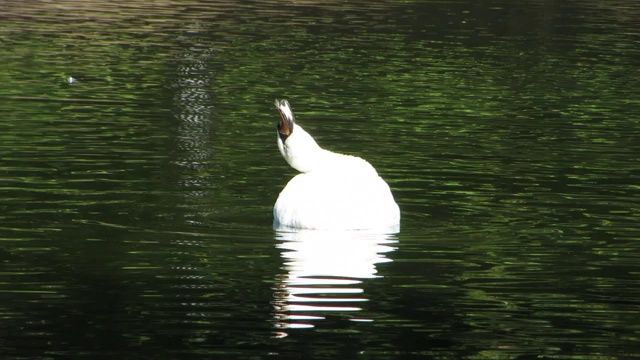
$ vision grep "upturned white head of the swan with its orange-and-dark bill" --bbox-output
[276,100,323,172]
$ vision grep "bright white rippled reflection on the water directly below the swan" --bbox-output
[273,230,398,336]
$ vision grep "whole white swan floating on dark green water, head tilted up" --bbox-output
[273,100,400,233]
